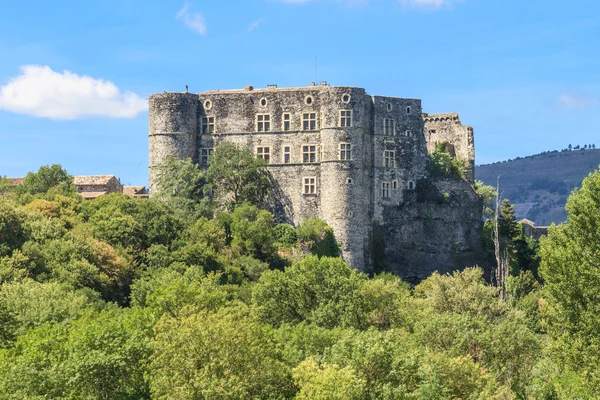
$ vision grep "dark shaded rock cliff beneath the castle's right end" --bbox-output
[372,180,482,284]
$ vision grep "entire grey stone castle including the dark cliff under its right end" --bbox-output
[149,83,481,282]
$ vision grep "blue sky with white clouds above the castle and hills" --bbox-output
[0,0,600,184]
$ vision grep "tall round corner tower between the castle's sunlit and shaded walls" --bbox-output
[320,87,372,271]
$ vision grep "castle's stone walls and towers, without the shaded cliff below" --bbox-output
[149,84,482,280]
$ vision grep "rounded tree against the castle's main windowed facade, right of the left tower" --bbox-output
[208,142,273,207]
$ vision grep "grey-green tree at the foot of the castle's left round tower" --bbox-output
[154,157,212,218]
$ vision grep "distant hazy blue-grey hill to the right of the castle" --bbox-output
[475,149,600,225]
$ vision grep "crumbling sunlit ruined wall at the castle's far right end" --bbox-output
[423,113,475,183]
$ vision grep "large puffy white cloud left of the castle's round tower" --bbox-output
[0,65,148,119]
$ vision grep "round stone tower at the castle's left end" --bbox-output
[148,92,198,195]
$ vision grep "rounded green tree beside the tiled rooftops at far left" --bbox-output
[15,164,76,194]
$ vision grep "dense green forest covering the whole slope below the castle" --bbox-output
[0,145,600,400]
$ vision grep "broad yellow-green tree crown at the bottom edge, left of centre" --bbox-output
[149,305,295,399]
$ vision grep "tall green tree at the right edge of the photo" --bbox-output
[540,170,600,396]
